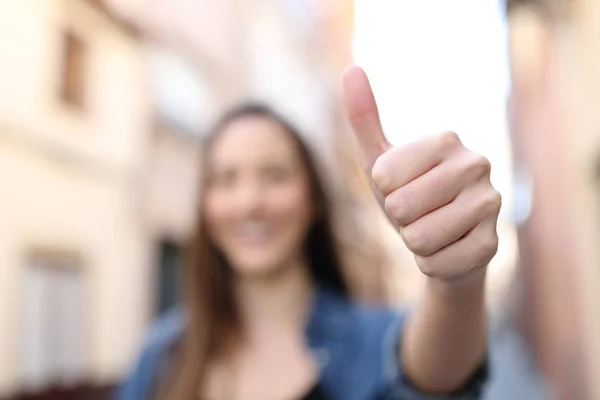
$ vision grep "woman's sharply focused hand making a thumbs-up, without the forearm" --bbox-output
[343,66,502,280]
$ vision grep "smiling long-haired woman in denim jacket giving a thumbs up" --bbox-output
[121,67,499,400]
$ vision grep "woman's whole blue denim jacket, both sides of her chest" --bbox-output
[117,289,487,400]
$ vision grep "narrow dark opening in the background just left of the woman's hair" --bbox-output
[157,241,181,315]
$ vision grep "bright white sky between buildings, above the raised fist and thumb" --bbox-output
[353,0,510,192]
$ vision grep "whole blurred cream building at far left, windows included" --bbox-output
[0,0,151,397]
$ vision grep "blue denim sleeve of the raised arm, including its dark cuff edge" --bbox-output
[319,290,487,400]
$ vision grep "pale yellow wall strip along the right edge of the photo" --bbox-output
[559,0,600,399]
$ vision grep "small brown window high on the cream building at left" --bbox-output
[60,31,86,107]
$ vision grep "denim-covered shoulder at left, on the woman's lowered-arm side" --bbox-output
[116,308,185,400]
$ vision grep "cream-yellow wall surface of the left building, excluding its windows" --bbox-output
[0,0,151,397]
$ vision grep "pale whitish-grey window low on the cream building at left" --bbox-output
[19,254,86,391]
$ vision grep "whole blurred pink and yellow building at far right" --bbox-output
[508,0,600,399]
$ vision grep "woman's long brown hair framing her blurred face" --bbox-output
[160,104,349,400]
